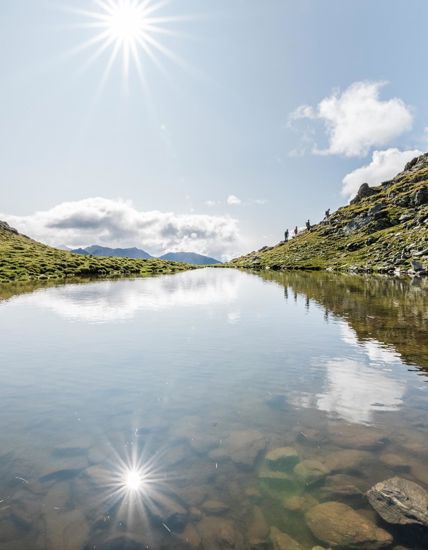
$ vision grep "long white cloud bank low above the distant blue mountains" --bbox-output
[0,197,240,258]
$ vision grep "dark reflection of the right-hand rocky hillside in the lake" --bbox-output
[259,272,428,371]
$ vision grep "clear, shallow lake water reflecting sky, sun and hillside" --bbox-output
[0,269,428,550]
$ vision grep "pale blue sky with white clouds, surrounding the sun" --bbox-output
[0,0,428,257]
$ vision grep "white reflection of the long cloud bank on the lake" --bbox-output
[5,269,240,323]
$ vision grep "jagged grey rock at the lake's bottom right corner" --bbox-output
[367,477,428,527]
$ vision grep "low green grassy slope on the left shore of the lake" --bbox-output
[0,222,194,283]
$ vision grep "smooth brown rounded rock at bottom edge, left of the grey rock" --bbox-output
[305,502,392,550]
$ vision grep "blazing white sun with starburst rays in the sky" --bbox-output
[71,0,186,85]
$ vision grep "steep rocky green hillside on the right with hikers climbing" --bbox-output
[231,153,428,272]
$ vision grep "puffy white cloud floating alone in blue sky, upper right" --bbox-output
[290,82,413,157]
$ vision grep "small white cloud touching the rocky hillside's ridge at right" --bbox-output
[342,148,422,198]
